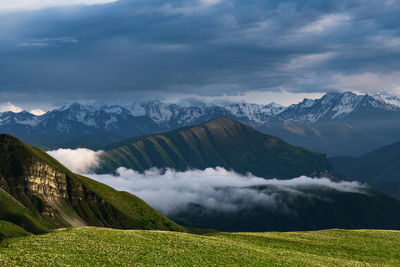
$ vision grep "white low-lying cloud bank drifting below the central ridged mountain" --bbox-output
[48,148,365,216]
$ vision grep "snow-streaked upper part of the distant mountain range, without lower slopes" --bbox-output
[0,92,400,132]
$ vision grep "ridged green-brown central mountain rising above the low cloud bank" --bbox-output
[97,117,332,179]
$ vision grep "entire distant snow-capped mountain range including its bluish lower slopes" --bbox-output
[0,92,400,156]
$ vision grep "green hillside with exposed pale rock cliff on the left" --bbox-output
[0,134,183,237]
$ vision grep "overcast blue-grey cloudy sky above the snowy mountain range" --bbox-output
[0,0,400,110]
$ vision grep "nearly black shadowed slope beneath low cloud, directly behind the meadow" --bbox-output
[172,186,400,232]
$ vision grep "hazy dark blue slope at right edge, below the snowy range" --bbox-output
[330,142,400,198]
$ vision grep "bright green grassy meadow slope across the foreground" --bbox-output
[0,227,400,266]
